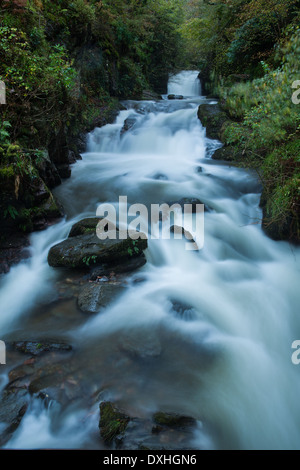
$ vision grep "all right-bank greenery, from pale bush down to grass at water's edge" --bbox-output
[218,26,300,241]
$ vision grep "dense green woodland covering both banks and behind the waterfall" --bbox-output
[0,0,300,253]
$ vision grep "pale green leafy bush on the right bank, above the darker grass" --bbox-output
[219,29,300,151]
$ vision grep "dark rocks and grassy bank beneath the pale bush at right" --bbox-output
[198,97,300,245]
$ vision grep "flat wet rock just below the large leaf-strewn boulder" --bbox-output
[77,282,125,313]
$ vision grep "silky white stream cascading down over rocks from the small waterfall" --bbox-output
[0,71,300,449]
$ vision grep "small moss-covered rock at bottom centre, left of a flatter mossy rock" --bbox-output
[99,402,130,444]
